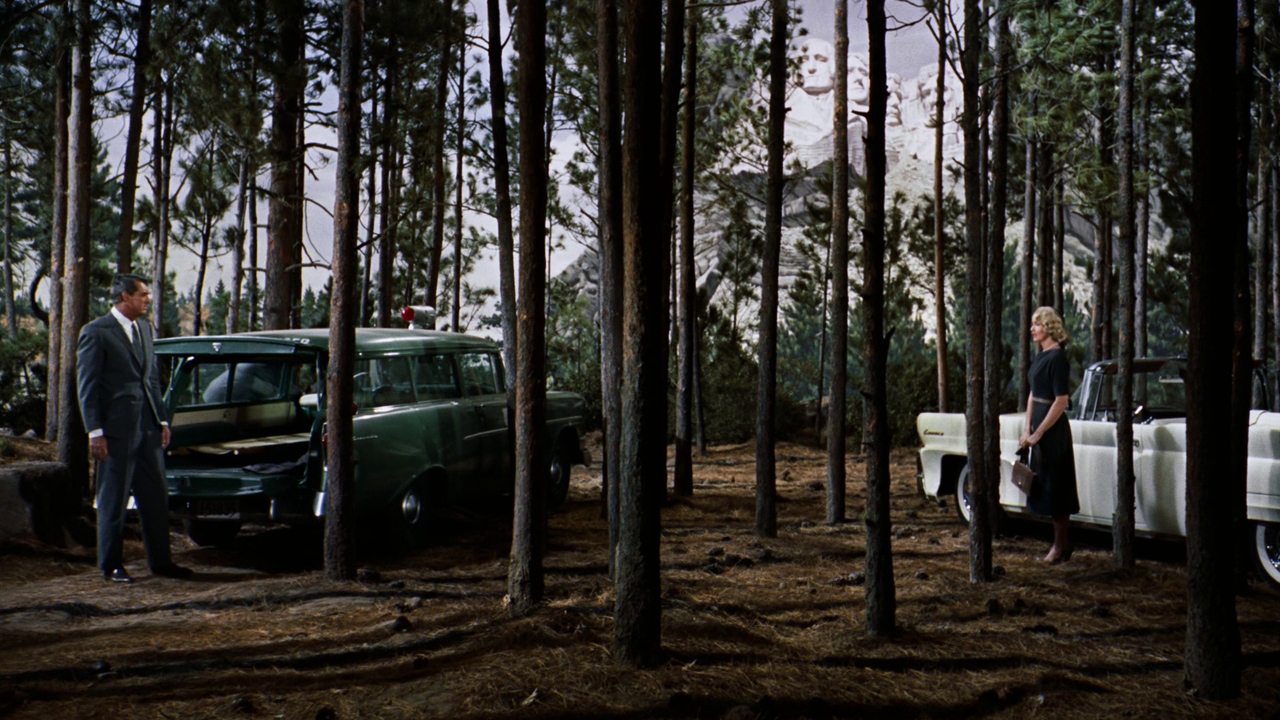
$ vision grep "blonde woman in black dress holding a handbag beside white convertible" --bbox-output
[1020,302,1080,562]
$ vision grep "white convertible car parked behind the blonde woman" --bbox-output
[916,357,1280,587]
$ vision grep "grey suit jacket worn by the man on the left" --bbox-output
[77,314,168,438]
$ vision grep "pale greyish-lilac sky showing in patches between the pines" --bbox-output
[99,0,937,330]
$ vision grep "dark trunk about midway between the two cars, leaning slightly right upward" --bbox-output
[755,0,790,538]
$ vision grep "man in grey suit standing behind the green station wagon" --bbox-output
[77,275,191,583]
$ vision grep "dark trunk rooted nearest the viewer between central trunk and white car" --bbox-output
[863,0,896,637]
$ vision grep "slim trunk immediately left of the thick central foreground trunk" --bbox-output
[595,0,623,571]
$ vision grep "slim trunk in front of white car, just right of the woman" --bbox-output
[1111,0,1137,569]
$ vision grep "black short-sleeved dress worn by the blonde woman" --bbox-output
[1027,347,1080,516]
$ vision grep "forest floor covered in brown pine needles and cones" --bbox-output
[0,435,1280,720]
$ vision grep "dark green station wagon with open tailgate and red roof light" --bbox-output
[156,328,590,544]
